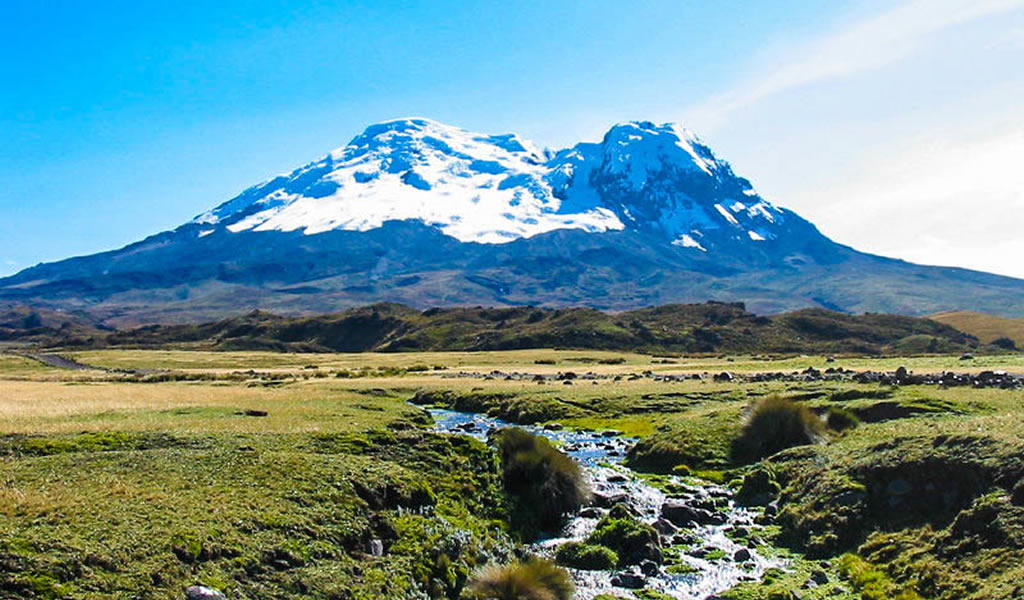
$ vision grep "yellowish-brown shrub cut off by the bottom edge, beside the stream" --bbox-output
[469,557,572,600]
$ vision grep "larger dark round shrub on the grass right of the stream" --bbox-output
[732,395,824,463]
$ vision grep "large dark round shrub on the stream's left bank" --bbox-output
[492,427,590,538]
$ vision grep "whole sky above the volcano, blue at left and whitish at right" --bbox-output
[6,0,1024,276]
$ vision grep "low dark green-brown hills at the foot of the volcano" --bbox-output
[37,302,980,354]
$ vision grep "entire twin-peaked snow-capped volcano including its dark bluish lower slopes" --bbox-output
[0,119,1024,321]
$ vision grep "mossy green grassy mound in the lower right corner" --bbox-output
[771,417,1024,600]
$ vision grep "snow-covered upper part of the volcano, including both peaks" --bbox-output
[194,119,784,250]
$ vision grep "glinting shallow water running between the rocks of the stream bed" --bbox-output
[430,409,782,600]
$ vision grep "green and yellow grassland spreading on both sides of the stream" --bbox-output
[0,350,1024,600]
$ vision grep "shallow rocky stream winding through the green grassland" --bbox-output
[430,409,784,600]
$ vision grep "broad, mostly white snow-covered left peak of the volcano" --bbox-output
[196,119,623,244]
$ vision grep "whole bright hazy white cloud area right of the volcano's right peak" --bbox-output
[671,0,1024,277]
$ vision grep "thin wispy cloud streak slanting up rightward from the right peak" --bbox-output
[684,0,1024,132]
